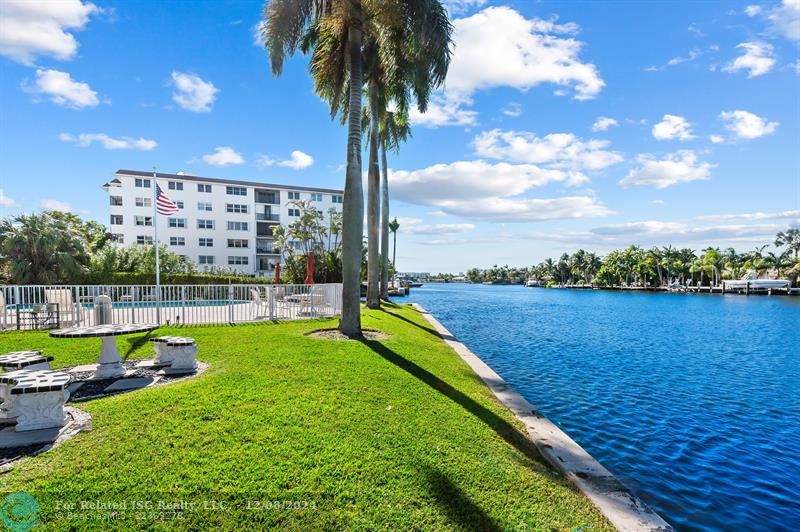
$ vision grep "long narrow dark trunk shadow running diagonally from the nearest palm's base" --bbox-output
[359,339,545,464]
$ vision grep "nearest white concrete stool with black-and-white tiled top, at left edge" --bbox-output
[0,369,70,432]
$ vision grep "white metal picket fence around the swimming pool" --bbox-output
[0,284,342,329]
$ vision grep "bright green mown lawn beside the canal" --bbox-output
[0,306,611,530]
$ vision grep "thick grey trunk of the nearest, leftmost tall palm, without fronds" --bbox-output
[339,26,364,337]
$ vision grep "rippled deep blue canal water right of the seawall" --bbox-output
[406,284,800,530]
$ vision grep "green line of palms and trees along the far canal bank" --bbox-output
[466,228,800,287]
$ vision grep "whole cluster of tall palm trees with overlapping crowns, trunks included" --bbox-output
[262,0,452,337]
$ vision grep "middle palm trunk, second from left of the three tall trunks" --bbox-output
[367,80,381,308]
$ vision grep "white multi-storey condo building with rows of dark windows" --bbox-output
[103,170,344,277]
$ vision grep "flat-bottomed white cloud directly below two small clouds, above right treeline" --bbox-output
[619,150,715,188]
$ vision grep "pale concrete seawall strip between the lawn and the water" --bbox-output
[413,304,674,531]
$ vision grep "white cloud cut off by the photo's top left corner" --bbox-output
[0,0,101,65]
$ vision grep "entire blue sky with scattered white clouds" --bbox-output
[0,0,800,271]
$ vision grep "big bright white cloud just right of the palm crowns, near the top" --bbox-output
[447,7,605,100]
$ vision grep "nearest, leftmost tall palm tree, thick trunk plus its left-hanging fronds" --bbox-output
[262,0,372,337]
